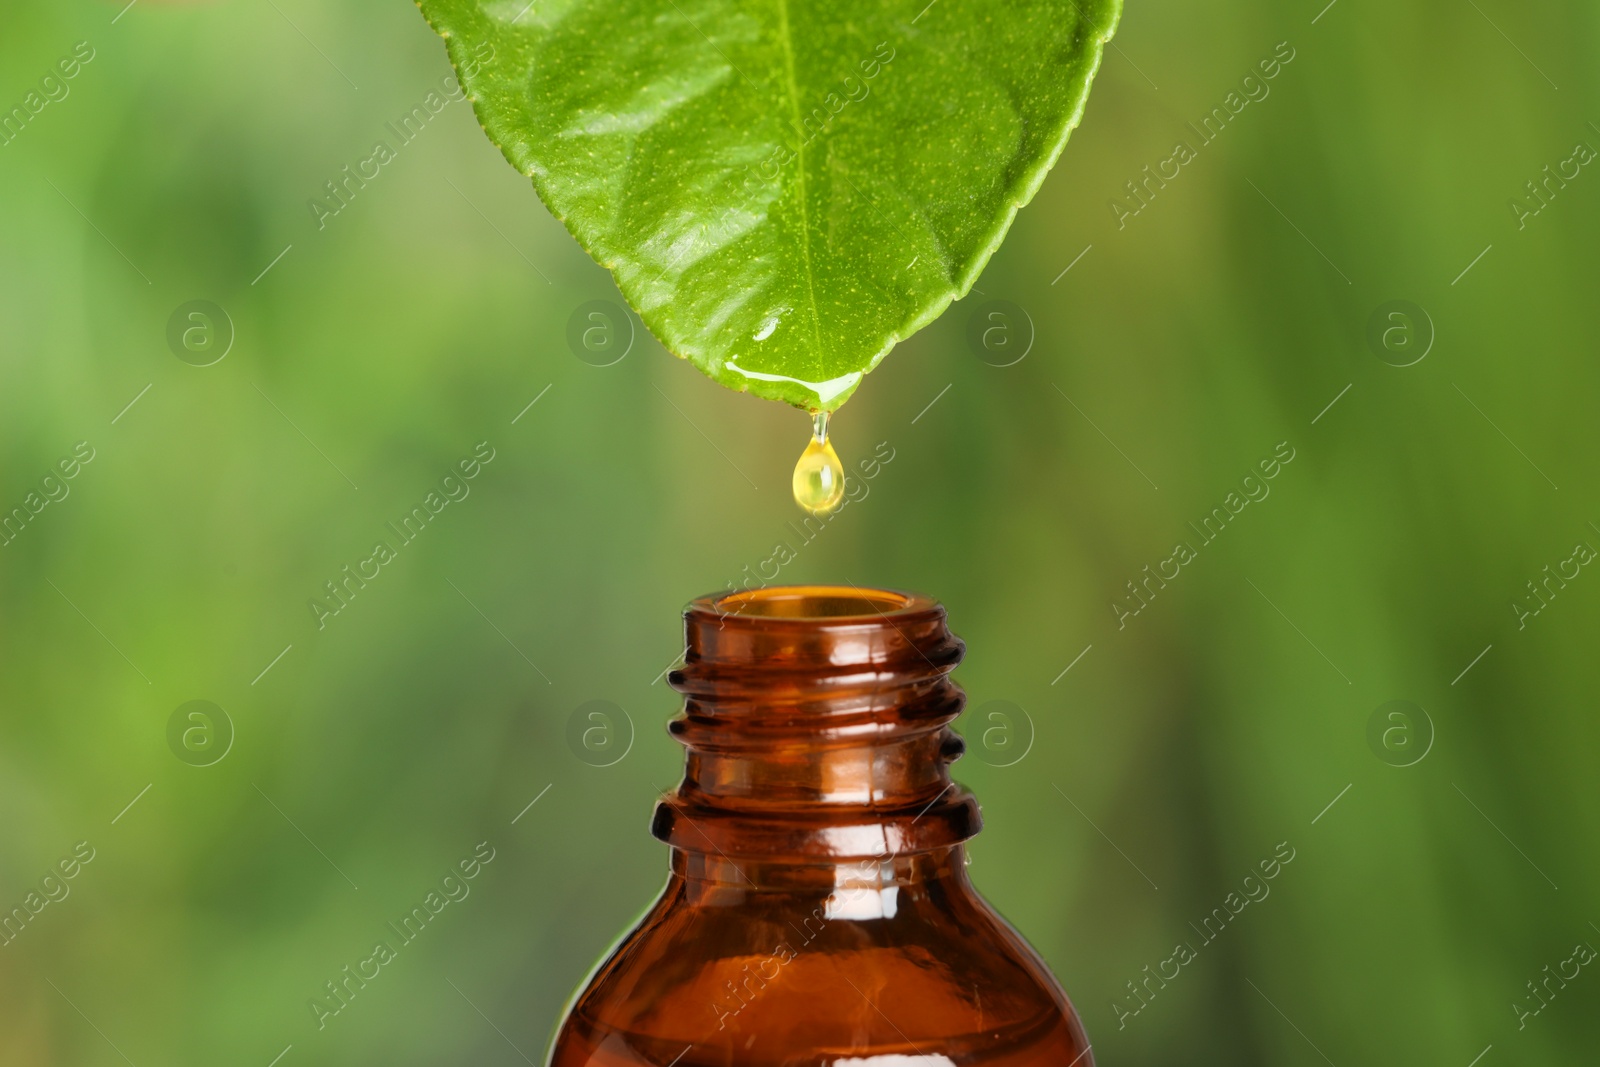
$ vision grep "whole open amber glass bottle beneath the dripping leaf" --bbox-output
[550,585,1094,1067]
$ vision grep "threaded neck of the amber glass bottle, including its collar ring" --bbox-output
[653,587,981,885]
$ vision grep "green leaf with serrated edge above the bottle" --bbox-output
[418,0,1122,411]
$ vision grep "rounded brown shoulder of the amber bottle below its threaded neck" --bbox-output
[552,878,1093,1067]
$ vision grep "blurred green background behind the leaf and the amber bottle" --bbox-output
[0,0,1600,1067]
